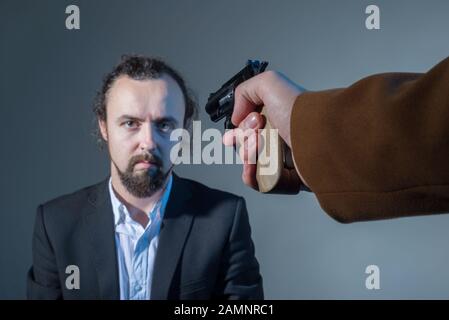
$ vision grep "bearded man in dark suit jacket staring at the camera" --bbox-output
[28,56,263,299]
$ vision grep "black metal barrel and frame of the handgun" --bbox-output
[206,60,268,129]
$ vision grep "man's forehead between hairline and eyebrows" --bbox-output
[107,74,185,121]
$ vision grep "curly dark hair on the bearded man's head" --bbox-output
[93,55,197,148]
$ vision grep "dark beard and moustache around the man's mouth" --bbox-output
[113,153,170,198]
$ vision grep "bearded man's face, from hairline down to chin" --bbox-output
[99,74,185,198]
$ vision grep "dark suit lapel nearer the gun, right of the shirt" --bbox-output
[151,174,193,300]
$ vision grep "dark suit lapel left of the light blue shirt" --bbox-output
[84,178,120,300]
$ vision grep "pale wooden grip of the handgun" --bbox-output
[256,108,288,193]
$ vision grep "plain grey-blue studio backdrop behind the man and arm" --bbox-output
[0,0,449,299]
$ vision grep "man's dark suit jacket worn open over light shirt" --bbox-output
[27,175,263,299]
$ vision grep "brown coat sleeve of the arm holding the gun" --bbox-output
[291,58,449,222]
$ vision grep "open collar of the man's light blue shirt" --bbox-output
[109,174,173,226]
